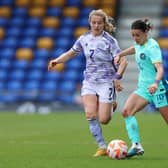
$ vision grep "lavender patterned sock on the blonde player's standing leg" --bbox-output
[88,119,106,148]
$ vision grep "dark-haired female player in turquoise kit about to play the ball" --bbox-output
[115,19,168,157]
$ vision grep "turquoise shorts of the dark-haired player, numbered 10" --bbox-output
[134,86,168,108]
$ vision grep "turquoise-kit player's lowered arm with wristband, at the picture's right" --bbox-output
[148,63,163,94]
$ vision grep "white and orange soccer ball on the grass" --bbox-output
[107,139,128,159]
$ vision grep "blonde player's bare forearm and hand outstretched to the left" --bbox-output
[48,49,77,70]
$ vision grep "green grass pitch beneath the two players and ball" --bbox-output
[0,112,168,168]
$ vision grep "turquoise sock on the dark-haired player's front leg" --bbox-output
[125,116,140,143]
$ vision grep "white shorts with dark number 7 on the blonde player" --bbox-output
[81,81,116,103]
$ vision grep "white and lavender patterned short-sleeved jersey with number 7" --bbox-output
[72,31,121,83]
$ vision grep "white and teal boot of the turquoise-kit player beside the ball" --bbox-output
[127,144,144,158]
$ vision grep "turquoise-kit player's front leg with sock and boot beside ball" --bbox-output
[123,93,148,157]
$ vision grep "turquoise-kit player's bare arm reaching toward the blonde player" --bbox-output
[114,46,135,64]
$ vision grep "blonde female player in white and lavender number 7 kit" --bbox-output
[48,9,127,156]
